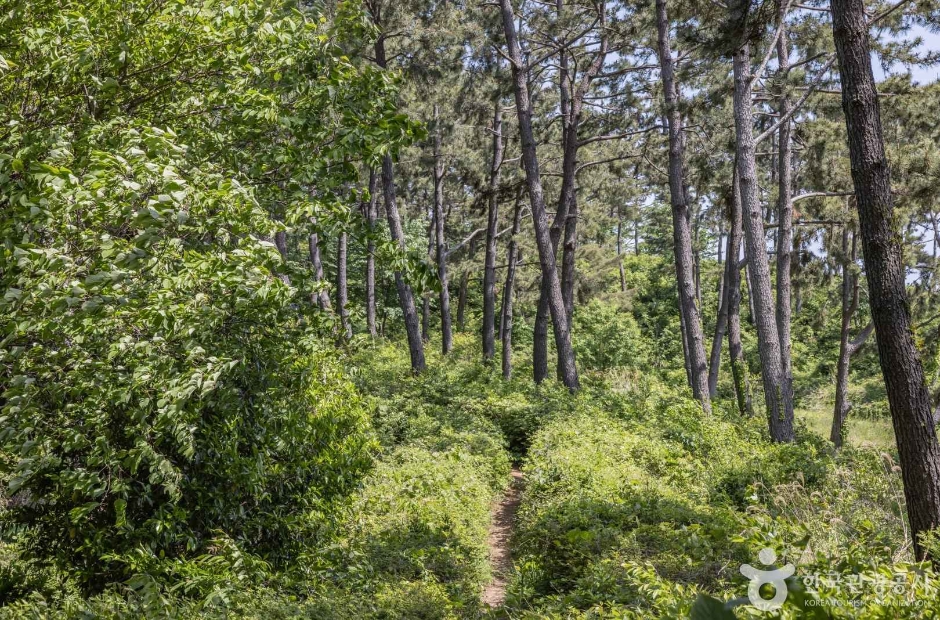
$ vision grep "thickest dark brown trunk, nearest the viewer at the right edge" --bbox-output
[832,0,940,558]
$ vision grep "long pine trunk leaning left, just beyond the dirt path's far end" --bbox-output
[500,0,579,390]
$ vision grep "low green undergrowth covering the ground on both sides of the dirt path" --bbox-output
[0,324,937,620]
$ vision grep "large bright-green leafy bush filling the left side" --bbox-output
[0,0,415,591]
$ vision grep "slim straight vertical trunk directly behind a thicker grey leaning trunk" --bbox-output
[776,15,793,426]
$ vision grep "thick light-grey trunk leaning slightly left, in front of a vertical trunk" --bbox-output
[733,45,793,442]
